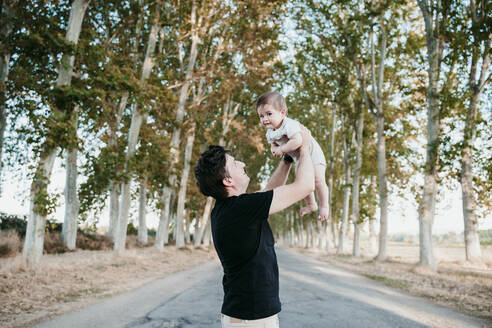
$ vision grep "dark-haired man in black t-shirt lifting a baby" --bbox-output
[195,130,314,327]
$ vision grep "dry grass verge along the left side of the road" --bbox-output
[0,245,215,327]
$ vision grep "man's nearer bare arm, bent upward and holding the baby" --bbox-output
[269,131,314,214]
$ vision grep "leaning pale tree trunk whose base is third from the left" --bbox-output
[114,2,161,254]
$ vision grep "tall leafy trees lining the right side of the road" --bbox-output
[268,0,492,267]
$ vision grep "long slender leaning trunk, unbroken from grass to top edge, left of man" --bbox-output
[154,1,201,249]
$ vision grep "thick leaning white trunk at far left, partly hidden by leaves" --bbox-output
[23,0,90,266]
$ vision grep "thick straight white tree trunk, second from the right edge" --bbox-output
[417,0,444,268]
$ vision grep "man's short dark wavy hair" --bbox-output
[195,146,231,199]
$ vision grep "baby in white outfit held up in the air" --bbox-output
[256,91,328,220]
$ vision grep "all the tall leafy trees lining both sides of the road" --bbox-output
[0,0,492,266]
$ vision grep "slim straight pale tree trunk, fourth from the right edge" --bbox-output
[352,112,364,257]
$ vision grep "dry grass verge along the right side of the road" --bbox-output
[295,243,492,322]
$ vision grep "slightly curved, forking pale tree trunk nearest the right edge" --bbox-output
[460,13,492,262]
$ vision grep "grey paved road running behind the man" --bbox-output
[32,249,492,328]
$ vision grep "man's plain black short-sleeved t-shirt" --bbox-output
[211,190,280,320]
